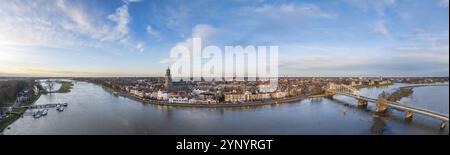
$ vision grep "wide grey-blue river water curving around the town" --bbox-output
[2,82,449,135]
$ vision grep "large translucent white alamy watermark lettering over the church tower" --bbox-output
[170,38,278,92]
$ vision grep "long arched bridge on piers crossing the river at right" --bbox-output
[325,84,448,129]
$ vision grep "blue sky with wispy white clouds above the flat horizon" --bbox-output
[0,0,449,77]
